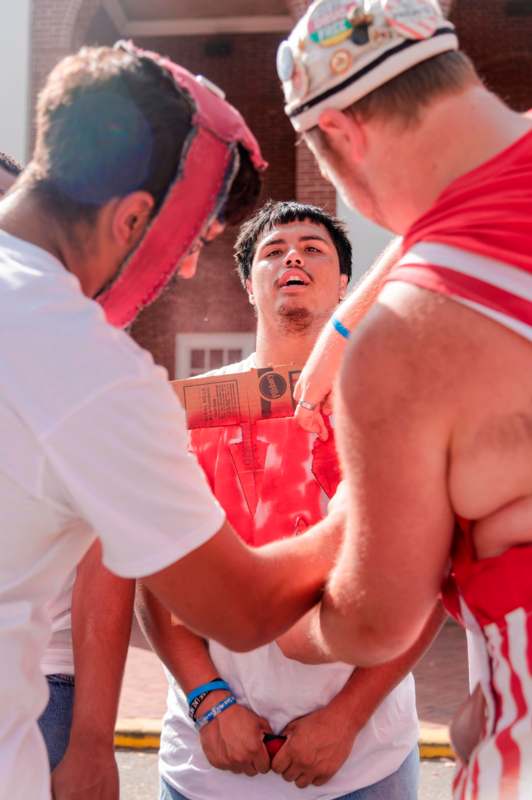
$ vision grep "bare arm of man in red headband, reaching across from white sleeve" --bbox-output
[143,514,343,650]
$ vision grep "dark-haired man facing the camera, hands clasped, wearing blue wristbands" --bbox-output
[136,201,438,800]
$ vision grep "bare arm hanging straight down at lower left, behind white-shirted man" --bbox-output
[53,541,135,800]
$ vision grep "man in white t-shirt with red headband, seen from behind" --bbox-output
[0,45,340,800]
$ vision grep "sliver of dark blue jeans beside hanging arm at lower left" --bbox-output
[39,675,74,772]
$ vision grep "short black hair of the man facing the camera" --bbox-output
[234,200,352,286]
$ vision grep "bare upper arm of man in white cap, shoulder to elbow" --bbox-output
[312,285,462,665]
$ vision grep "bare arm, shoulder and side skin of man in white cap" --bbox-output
[321,284,532,663]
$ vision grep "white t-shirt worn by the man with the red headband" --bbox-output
[0,231,224,800]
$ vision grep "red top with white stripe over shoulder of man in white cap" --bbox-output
[388,122,532,340]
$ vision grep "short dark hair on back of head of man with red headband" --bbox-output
[28,47,192,222]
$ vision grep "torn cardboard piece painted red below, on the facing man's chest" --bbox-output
[173,365,339,532]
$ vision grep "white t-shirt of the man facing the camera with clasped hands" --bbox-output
[159,355,418,800]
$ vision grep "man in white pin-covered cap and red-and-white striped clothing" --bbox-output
[278,0,532,800]
